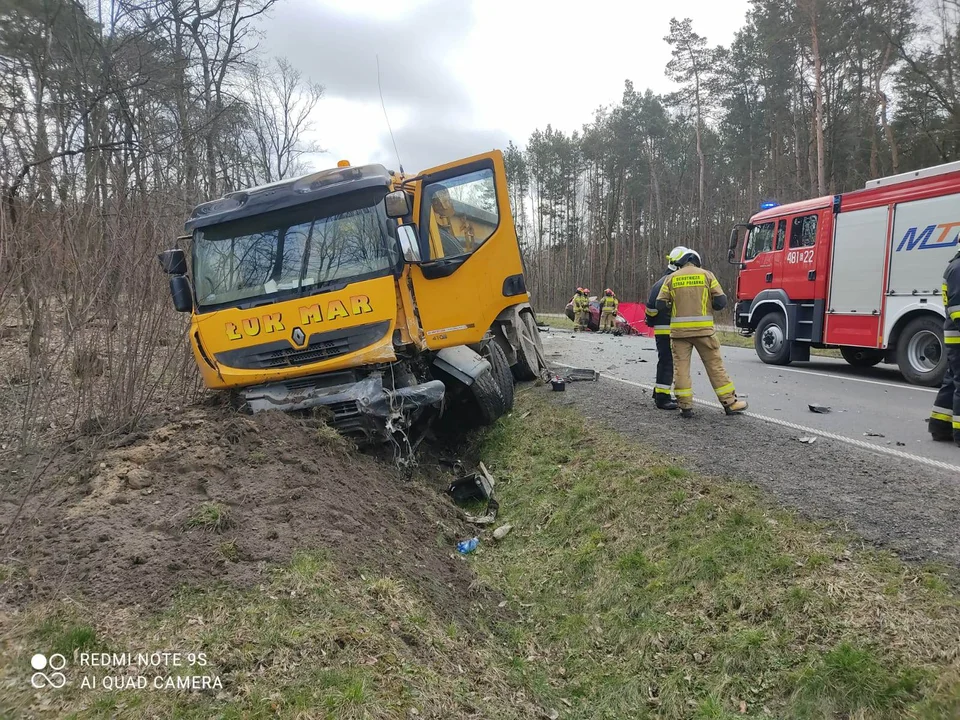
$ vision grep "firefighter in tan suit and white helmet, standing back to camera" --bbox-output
[657,249,747,418]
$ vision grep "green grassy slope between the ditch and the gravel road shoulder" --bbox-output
[476,393,960,720]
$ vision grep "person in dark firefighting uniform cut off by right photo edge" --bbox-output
[927,252,960,447]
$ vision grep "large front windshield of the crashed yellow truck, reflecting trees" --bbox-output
[193,192,399,309]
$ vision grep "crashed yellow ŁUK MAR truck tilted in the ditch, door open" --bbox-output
[160,151,545,442]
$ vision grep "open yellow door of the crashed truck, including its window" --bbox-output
[411,151,530,350]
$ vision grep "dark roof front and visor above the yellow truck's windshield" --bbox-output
[184,165,393,232]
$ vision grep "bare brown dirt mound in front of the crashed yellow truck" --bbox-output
[0,407,478,615]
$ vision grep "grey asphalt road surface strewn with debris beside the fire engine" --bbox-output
[542,330,960,472]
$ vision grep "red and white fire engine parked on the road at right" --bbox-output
[729,157,960,386]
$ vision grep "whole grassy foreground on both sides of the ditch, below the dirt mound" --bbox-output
[0,388,960,720]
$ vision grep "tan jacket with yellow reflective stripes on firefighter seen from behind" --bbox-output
[657,263,727,338]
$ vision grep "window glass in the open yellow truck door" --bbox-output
[423,168,500,260]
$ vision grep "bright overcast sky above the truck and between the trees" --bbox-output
[260,0,748,172]
